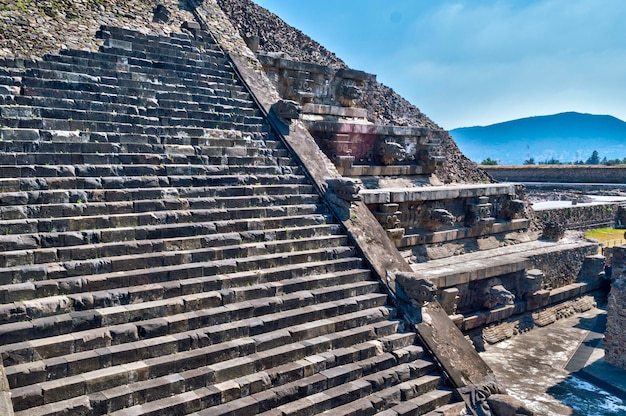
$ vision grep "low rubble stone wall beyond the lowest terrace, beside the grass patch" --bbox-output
[534,203,619,231]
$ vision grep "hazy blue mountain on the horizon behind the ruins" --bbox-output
[450,112,626,165]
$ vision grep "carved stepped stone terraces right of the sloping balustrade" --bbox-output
[220,0,602,354]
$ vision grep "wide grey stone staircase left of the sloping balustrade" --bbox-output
[0,27,459,416]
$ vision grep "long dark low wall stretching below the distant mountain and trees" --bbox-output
[480,165,626,183]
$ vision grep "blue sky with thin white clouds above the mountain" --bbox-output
[255,0,626,130]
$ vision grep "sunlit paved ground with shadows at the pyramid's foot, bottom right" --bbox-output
[480,302,626,416]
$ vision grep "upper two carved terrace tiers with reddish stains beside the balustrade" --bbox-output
[258,54,444,177]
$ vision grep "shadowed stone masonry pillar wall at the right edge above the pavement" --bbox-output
[604,246,626,370]
